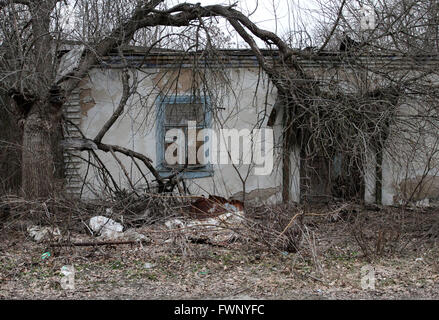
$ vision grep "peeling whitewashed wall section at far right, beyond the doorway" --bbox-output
[382,90,439,205]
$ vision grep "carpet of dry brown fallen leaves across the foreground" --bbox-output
[0,206,439,299]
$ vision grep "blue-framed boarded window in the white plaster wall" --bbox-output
[156,95,213,178]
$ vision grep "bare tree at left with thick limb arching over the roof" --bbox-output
[0,0,285,198]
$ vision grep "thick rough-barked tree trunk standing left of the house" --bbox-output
[22,109,58,199]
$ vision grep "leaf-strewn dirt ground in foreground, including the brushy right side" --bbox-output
[0,202,439,299]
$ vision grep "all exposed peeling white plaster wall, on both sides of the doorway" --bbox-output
[62,51,439,205]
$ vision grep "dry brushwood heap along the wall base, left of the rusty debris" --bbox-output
[0,190,188,238]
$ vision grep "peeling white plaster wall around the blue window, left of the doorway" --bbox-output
[70,68,298,202]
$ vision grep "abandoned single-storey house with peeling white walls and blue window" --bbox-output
[59,47,439,205]
